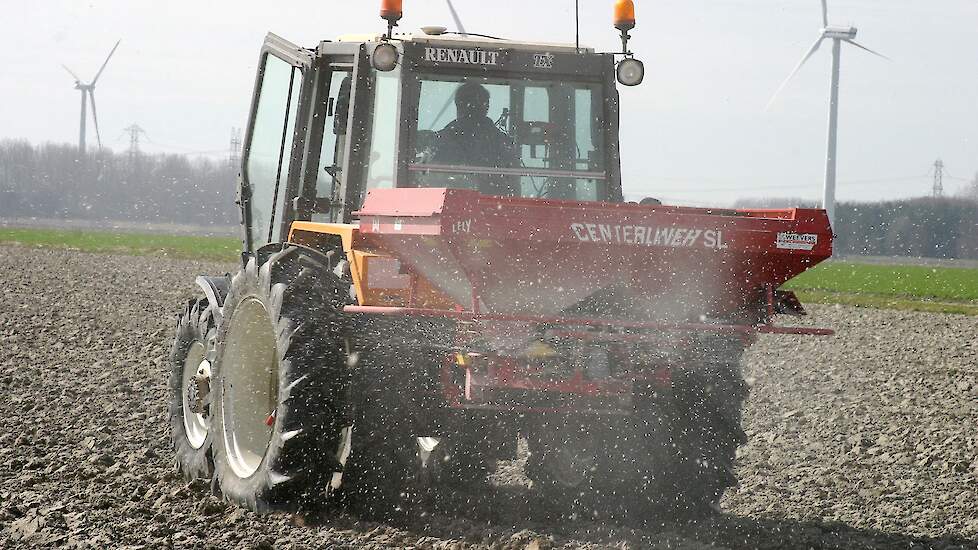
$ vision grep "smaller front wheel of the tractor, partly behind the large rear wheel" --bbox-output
[167,298,216,481]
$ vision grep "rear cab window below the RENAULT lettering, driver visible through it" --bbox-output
[408,75,607,200]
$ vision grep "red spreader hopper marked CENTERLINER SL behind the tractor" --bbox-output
[349,189,832,333]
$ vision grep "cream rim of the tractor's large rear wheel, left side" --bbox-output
[221,297,278,478]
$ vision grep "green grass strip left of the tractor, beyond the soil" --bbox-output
[0,228,241,262]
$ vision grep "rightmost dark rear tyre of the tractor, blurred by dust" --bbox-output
[649,352,748,519]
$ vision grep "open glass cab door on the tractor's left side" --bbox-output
[238,34,315,253]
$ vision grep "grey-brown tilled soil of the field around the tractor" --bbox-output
[0,246,978,549]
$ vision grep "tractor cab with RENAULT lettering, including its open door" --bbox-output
[238,27,637,252]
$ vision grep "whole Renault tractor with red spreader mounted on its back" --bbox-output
[168,0,832,517]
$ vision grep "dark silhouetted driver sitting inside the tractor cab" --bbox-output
[432,82,519,196]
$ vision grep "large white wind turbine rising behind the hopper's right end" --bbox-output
[767,0,889,227]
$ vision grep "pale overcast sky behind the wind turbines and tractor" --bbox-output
[0,0,978,204]
